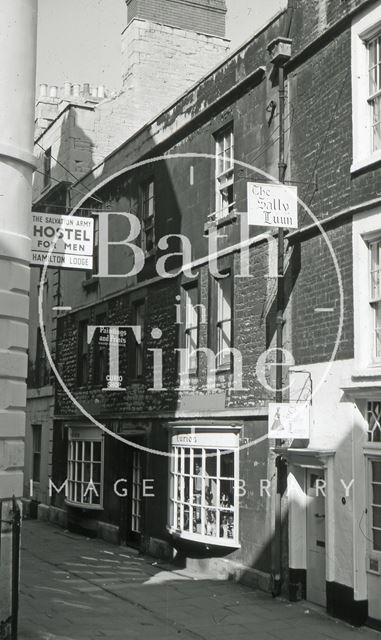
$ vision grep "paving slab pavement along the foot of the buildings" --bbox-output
[19,520,381,640]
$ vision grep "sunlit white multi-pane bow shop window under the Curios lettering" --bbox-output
[168,428,240,548]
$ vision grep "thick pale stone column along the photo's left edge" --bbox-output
[0,0,37,500]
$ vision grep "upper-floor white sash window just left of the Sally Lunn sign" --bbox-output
[214,122,236,222]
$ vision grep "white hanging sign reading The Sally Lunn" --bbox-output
[247,182,298,229]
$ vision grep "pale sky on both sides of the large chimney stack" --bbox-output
[37,0,284,89]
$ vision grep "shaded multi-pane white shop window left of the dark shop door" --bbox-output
[65,427,104,511]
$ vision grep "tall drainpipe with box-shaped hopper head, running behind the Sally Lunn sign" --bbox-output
[268,29,291,597]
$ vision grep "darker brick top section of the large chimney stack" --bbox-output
[127,0,226,38]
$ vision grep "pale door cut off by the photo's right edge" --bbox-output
[367,459,381,620]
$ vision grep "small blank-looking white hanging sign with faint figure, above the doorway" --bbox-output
[268,402,310,440]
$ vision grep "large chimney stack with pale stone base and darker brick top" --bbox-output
[122,0,229,134]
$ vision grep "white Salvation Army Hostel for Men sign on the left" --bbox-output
[31,213,94,269]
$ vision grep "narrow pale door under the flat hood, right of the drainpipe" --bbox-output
[307,469,326,607]
